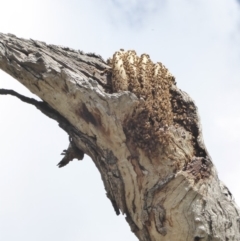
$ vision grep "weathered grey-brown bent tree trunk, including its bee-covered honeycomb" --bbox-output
[0,34,240,241]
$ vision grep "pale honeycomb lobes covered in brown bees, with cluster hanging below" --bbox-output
[109,50,175,154]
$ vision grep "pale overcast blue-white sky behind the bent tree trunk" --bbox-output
[0,0,240,241]
